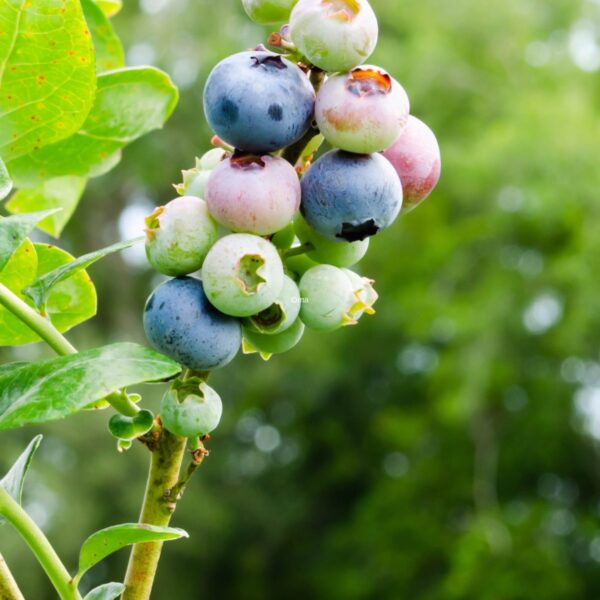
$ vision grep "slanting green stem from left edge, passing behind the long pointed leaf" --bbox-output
[0,283,139,417]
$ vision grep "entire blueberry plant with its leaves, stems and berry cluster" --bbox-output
[0,0,440,600]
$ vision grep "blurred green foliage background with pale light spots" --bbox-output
[0,0,600,600]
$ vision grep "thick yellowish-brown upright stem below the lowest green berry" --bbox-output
[122,429,187,600]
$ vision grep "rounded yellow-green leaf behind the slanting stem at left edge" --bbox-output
[0,241,96,346]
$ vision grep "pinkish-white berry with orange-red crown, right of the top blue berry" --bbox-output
[315,65,410,154]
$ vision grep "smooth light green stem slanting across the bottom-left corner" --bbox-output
[0,486,81,600]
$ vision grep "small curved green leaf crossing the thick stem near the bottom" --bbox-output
[75,523,189,580]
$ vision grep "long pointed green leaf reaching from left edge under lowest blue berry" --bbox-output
[0,343,181,429]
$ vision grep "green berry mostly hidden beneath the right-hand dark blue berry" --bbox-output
[294,215,369,267]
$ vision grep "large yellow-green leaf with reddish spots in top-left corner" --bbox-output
[0,0,95,163]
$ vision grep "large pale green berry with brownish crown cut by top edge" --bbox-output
[290,0,378,72]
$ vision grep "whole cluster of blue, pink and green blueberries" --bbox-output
[139,0,440,436]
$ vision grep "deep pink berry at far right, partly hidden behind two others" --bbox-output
[383,115,441,212]
